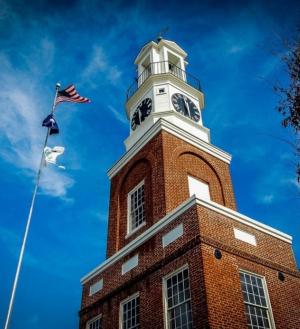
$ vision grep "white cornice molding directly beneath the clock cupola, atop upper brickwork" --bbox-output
[108,118,231,179]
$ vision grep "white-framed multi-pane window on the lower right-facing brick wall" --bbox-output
[240,272,274,329]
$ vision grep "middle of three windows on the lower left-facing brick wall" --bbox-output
[120,294,140,329]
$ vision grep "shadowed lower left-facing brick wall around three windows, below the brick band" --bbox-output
[80,245,207,329]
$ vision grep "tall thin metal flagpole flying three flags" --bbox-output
[4,83,60,329]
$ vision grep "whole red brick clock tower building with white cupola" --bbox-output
[79,39,300,329]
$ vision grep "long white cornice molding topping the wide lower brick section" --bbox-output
[80,195,292,284]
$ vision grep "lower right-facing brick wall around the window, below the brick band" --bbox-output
[201,244,300,329]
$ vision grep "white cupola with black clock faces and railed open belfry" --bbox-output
[125,39,210,150]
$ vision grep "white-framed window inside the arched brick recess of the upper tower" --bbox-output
[127,181,146,233]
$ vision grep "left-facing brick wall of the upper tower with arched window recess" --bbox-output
[107,135,166,257]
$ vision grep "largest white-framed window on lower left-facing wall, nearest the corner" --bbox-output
[164,267,193,329]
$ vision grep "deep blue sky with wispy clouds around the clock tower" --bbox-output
[0,0,300,329]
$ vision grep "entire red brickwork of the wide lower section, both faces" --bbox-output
[81,205,300,329]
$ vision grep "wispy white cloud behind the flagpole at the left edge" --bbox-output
[0,54,74,197]
